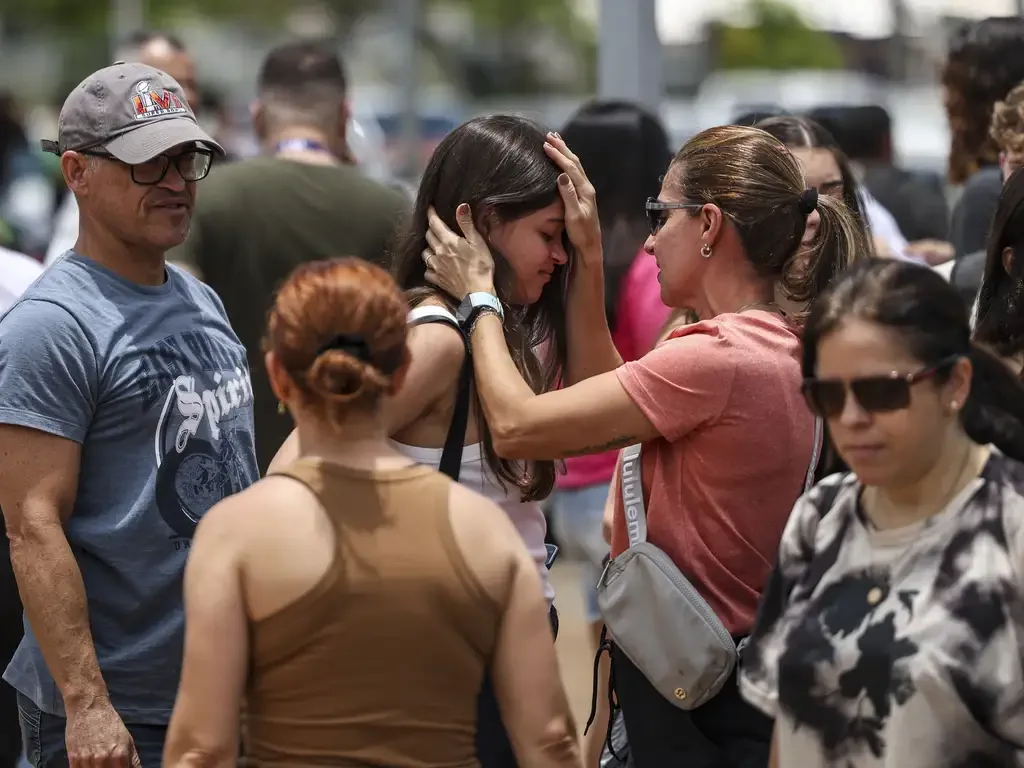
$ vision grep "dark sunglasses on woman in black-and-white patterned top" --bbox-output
[801,354,961,419]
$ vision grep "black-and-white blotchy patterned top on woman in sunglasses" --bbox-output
[739,450,1024,768]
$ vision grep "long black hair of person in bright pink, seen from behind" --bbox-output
[561,100,672,329]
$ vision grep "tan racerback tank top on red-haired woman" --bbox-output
[243,459,501,768]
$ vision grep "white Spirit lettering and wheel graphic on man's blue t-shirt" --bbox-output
[130,331,259,540]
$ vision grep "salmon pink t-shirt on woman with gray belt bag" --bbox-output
[611,310,814,636]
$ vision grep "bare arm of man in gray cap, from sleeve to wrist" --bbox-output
[0,424,109,710]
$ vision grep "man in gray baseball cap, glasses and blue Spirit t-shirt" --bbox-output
[0,62,258,768]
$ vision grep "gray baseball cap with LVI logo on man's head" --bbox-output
[42,61,224,165]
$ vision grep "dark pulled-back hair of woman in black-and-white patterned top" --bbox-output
[803,259,1024,461]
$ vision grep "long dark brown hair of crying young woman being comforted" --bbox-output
[392,115,573,501]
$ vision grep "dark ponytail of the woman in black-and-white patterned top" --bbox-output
[962,343,1024,462]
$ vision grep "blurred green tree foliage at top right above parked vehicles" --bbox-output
[716,0,844,70]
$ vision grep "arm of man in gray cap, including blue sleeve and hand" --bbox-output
[0,298,134,768]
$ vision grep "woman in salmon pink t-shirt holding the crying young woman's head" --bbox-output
[426,126,866,768]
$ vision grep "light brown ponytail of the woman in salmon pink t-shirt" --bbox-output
[781,195,870,319]
